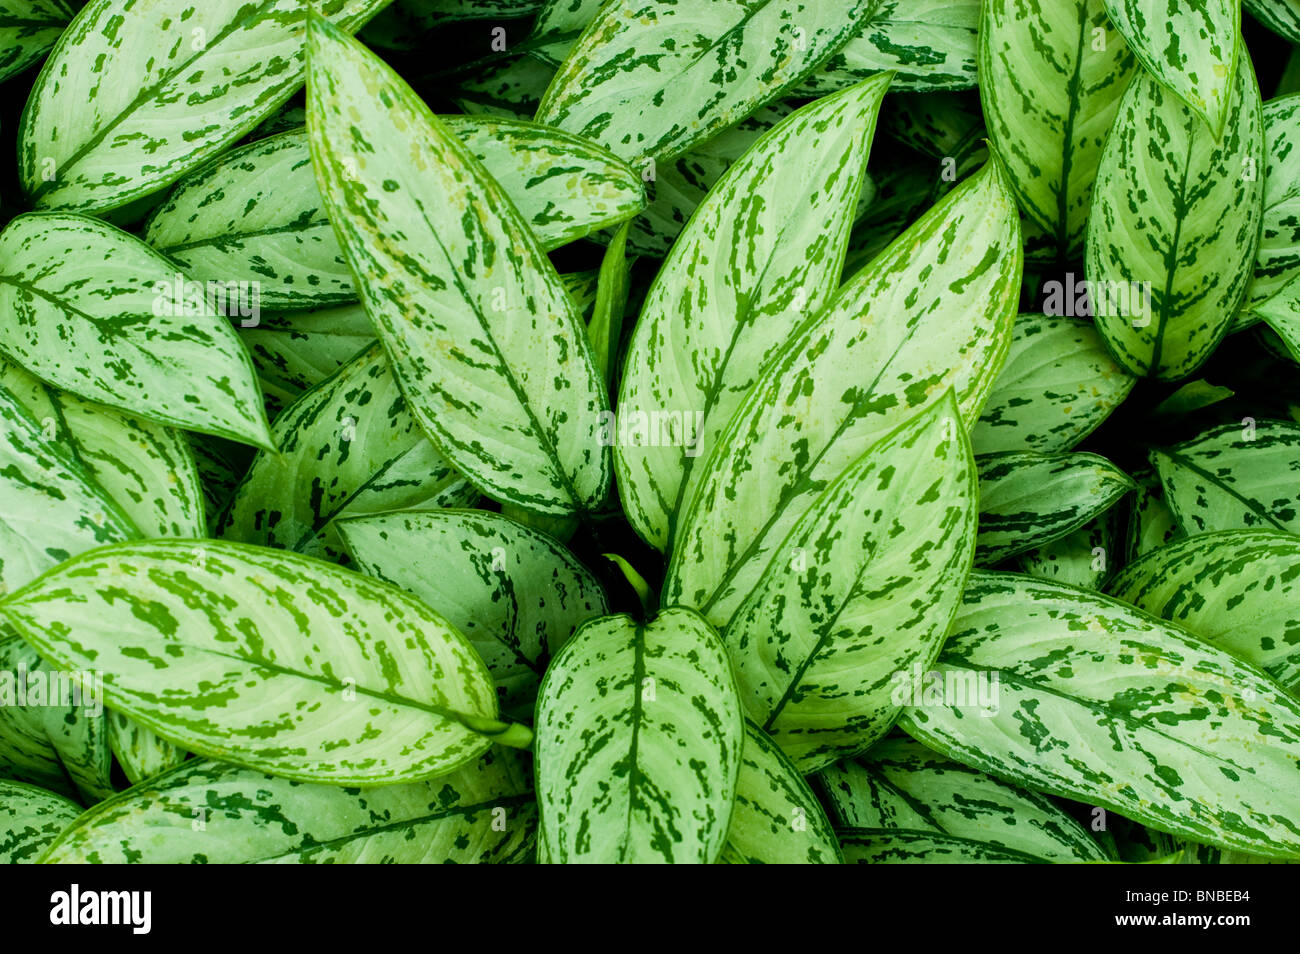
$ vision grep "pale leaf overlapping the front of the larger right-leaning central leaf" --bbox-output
[723,393,976,773]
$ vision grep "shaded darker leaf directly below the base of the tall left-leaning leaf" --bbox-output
[338,511,610,715]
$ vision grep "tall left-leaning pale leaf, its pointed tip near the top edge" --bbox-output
[307,18,610,515]
